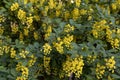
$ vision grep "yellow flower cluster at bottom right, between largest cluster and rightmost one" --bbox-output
[95,63,105,79]
